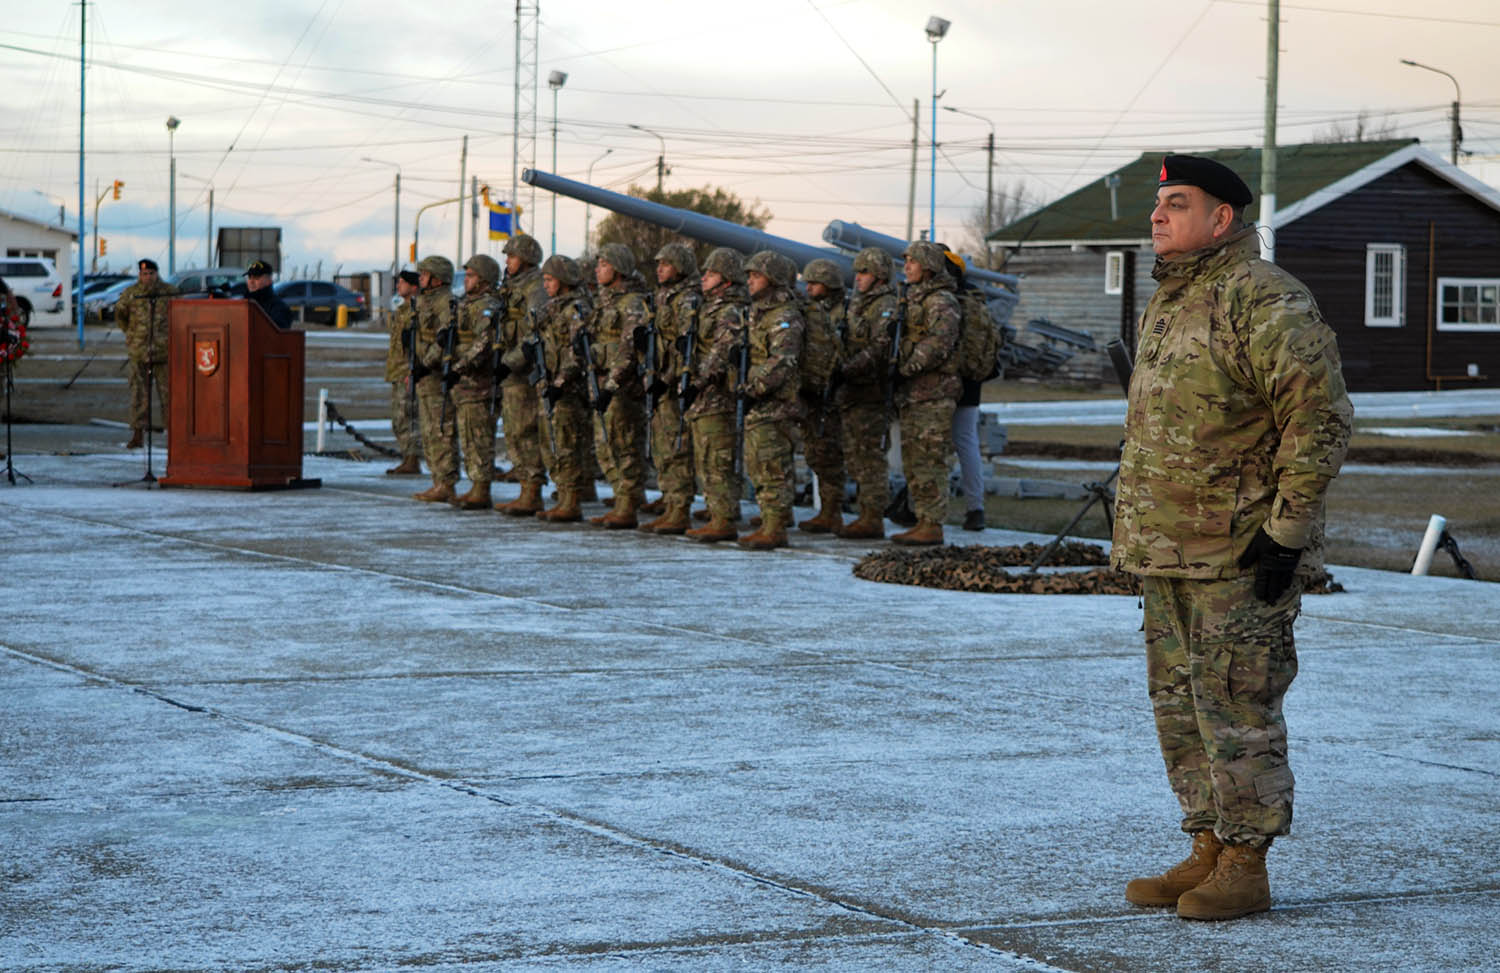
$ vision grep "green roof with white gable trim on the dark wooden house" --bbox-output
[989,138,1434,246]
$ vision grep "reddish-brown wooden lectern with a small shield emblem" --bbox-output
[161,298,321,490]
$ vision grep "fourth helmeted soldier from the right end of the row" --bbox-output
[740,250,807,550]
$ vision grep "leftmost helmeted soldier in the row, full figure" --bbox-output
[413,256,459,504]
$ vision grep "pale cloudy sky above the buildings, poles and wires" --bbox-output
[0,0,1500,276]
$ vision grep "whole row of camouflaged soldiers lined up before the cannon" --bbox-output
[387,227,963,550]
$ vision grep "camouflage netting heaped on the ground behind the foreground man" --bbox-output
[854,541,1344,595]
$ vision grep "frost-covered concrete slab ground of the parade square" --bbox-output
[0,443,1500,972]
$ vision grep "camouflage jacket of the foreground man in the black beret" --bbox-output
[1112,228,1353,579]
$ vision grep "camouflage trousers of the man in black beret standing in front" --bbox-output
[1142,574,1302,846]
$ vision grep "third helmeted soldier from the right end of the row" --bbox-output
[797,258,846,534]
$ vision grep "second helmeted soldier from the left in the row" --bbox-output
[452,253,504,510]
